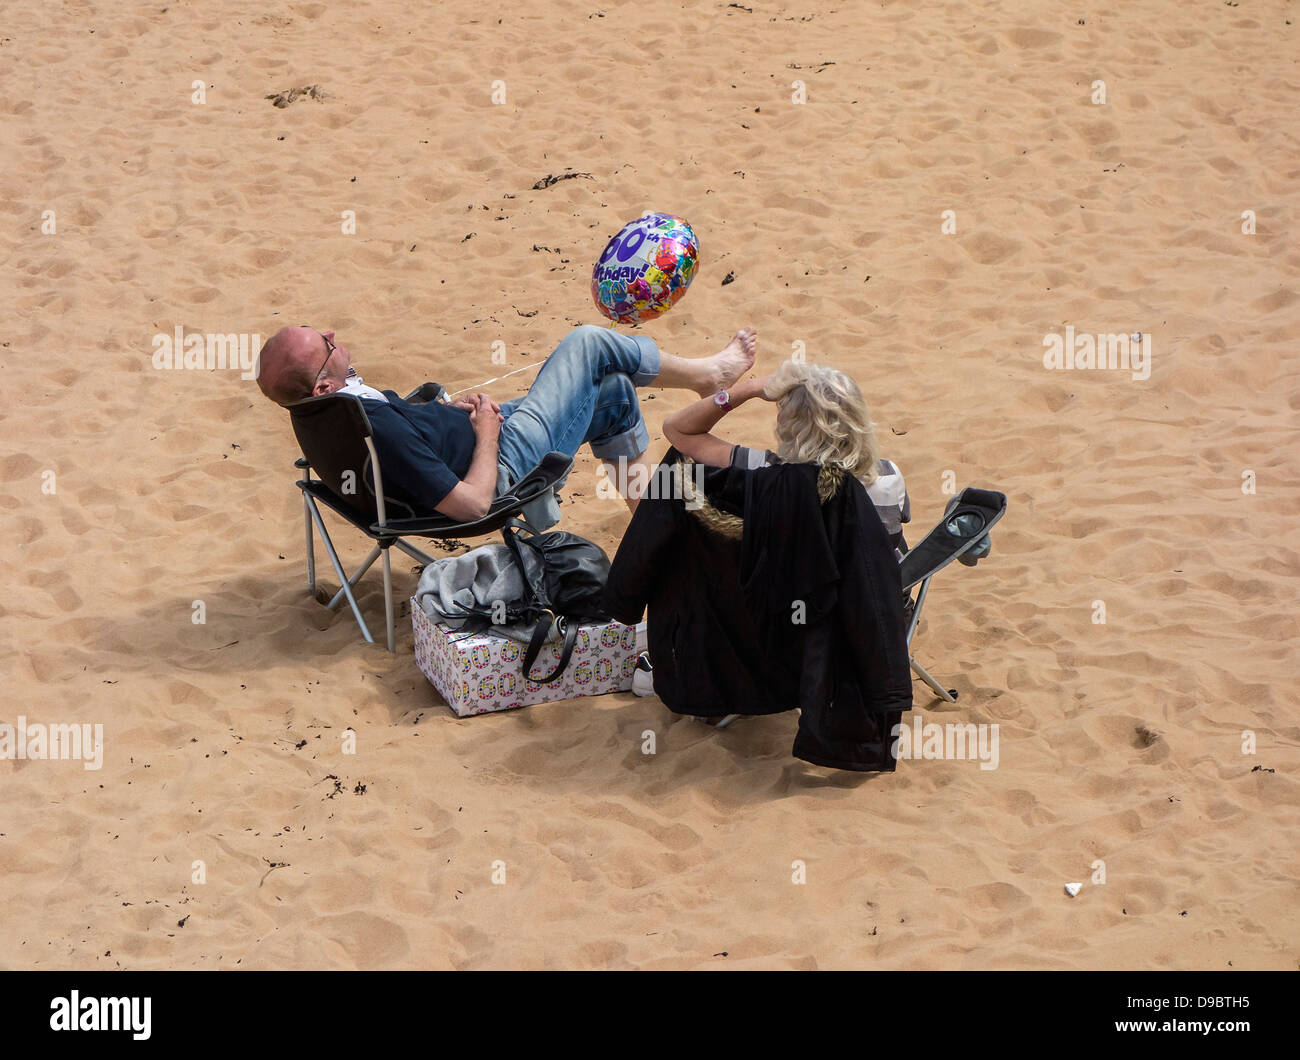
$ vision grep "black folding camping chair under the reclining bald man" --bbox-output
[289,382,573,652]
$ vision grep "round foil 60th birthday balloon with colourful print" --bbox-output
[592,213,699,324]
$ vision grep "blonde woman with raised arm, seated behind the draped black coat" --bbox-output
[663,360,911,555]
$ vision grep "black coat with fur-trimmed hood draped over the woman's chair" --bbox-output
[605,453,911,771]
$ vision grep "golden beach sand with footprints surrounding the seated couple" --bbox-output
[0,0,1300,969]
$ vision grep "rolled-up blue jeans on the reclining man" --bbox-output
[498,324,660,492]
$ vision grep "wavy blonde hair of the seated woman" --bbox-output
[763,360,879,486]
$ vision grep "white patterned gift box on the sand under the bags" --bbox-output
[411,598,645,718]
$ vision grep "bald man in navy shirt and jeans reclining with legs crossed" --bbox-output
[257,324,757,529]
